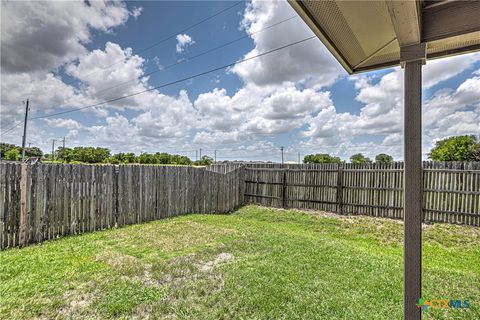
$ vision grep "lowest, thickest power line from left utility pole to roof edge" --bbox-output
[22,35,317,122]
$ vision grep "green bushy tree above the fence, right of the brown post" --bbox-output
[428,135,480,161]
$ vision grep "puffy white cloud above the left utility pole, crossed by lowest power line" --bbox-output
[1,42,151,131]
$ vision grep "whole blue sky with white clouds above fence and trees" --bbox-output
[0,0,480,161]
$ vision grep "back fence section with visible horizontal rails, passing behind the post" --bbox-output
[235,162,480,226]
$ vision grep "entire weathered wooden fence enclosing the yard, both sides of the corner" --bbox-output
[0,162,480,248]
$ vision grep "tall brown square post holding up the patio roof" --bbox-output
[404,60,423,320]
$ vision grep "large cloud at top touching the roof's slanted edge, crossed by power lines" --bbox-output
[231,0,346,88]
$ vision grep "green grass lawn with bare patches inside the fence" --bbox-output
[0,206,480,320]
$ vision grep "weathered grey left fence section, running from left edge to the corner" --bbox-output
[0,163,244,248]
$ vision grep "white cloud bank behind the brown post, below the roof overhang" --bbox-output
[304,65,480,158]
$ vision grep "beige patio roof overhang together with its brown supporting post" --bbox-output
[288,0,480,320]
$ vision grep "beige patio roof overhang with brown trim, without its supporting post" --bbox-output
[289,0,480,74]
